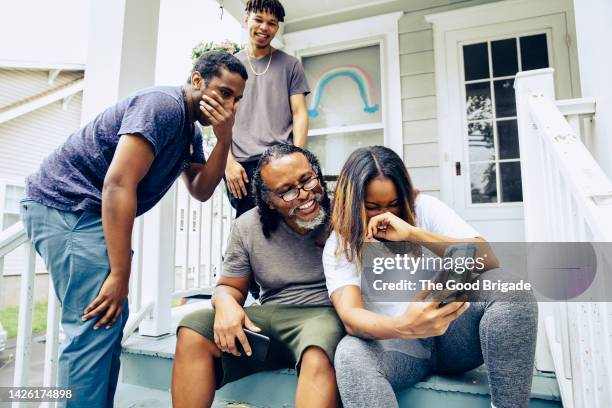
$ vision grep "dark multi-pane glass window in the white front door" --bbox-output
[462,34,549,204]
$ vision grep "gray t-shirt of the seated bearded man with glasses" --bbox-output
[222,207,331,306]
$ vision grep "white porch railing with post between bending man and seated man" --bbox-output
[124,181,233,341]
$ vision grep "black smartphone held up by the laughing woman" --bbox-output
[431,243,477,307]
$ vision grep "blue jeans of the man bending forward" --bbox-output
[20,198,129,408]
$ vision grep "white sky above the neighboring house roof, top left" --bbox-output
[0,0,91,64]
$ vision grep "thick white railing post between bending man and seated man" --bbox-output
[139,184,177,337]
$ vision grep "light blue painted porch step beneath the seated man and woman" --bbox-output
[117,302,562,408]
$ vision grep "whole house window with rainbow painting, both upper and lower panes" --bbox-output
[302,43,384,175]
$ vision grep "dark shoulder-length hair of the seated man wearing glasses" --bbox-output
[251,143,331,238]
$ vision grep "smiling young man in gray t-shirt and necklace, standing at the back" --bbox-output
[225,0,310,217]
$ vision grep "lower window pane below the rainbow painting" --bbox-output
[308,129,384,176]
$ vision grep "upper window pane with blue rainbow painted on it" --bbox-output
[302,45,382,129]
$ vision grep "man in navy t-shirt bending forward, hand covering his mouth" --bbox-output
[21,51,248,408]
